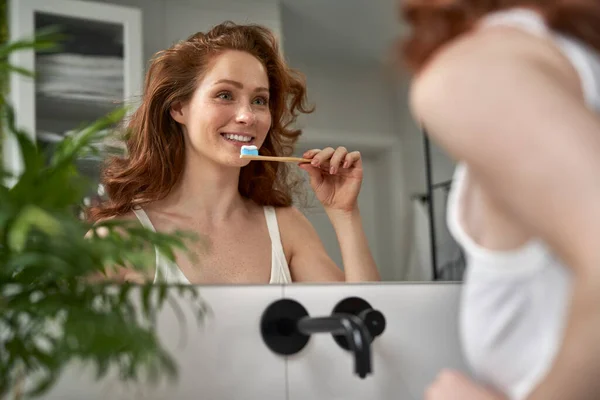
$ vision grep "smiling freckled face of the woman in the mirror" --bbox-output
[171,50,271,167]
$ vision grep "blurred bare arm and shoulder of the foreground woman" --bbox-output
[412,32,600,400]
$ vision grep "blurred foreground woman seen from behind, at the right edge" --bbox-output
[403,0,600,400]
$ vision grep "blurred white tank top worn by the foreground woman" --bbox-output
[447,9,600,399]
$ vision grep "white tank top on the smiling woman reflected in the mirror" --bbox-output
[133,207,292,285]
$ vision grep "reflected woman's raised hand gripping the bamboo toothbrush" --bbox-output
[300,147,363,212]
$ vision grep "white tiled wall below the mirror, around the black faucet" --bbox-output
[44,283,466,400]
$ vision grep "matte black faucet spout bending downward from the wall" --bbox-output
[296,313,373,378]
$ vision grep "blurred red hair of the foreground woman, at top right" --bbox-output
[401,0,600,72]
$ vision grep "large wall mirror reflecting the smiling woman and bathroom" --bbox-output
[9,0,464,283]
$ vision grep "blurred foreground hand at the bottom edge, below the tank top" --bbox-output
[425,370,507,400]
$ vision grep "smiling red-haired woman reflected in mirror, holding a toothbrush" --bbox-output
[90,23,379,284]
